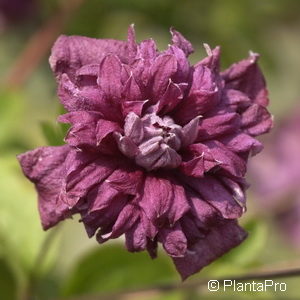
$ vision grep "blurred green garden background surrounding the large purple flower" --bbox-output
[0,0,300,300]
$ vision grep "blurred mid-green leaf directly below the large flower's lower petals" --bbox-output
[62,244,178,296]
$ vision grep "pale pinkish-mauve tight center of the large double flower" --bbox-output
[115,112,199,171]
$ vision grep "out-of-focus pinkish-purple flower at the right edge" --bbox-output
[250,107,300,249]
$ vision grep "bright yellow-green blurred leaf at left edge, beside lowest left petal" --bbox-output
[0,155,58,270]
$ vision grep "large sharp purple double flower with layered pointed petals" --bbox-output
[19,26,272,279]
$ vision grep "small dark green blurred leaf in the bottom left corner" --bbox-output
[0,258,17,300]
